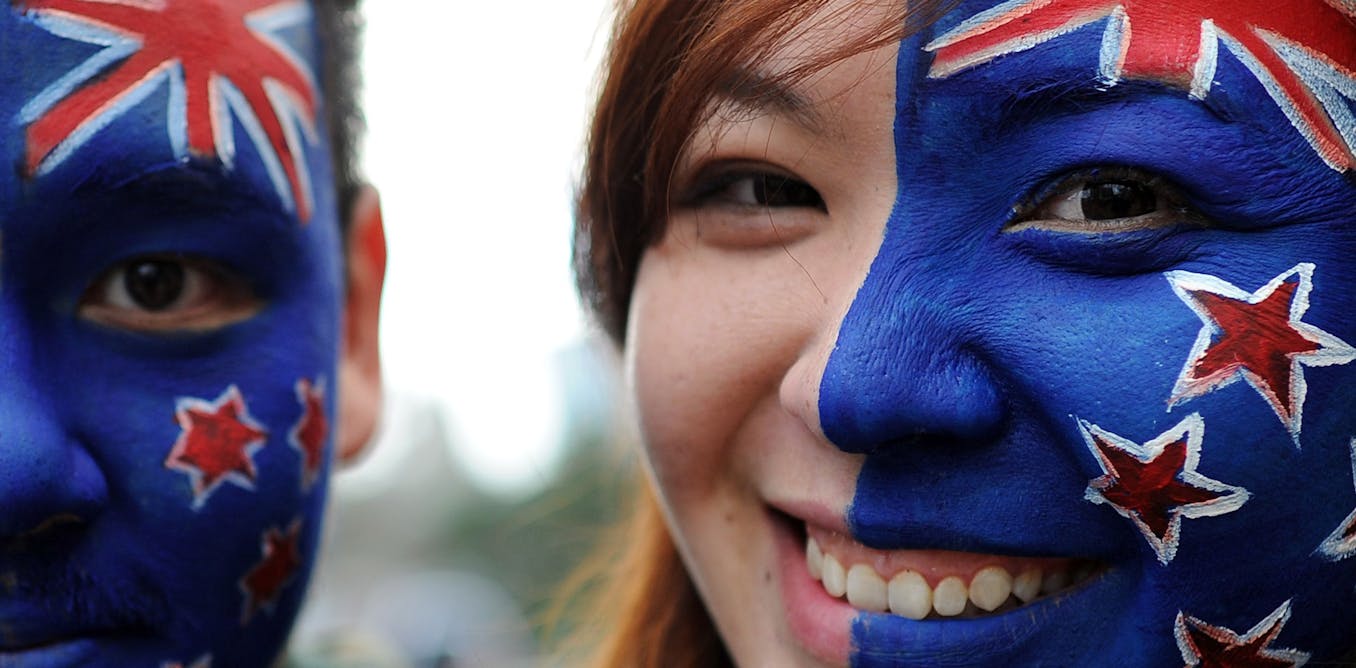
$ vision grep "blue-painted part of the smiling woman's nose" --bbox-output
[819,242,1005,453]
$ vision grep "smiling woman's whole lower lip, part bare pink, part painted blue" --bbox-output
[773,512,1135,667]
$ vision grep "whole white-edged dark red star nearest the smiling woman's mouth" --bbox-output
[1078,413,1249,565]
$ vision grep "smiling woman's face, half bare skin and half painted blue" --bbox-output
[628,0,1356,667]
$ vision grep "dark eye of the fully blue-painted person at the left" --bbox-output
[79,253,262,333]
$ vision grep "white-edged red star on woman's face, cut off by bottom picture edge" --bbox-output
[1174,600,1309,668]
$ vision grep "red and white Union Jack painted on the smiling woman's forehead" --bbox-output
[925,0,1356,172]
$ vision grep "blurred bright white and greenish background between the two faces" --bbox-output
[293,0,628,668]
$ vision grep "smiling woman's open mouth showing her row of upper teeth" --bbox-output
[805,530,1104,621]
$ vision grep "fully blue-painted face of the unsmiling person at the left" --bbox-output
[0,0,342,667]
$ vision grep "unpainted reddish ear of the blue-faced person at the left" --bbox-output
[335,186,386,463]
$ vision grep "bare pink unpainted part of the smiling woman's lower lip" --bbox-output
[773,514,857,665]
